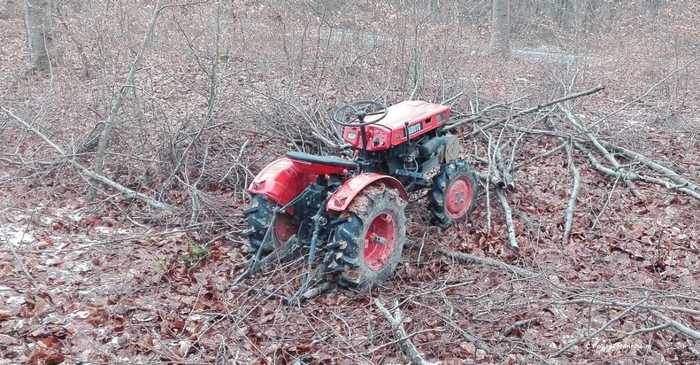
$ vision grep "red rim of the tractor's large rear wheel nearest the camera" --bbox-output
[364,213,396,271]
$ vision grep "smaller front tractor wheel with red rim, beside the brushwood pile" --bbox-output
[429,160,479,228]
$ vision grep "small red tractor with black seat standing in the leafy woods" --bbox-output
[245,101,478,288]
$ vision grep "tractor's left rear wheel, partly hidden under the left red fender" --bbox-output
[244,195,298,255]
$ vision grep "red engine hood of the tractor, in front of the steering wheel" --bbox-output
[343,100,450,151]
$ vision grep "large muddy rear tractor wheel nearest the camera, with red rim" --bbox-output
[326,184,406,289]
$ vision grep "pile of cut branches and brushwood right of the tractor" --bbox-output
[445,86,700,251]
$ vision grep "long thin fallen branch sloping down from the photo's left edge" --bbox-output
[0,107,176,212]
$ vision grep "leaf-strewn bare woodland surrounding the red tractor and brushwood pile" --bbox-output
[0,0,700,364]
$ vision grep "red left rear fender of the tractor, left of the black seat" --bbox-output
[248,157,318,205]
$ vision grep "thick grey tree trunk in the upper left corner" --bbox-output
[24,0,52,71]
